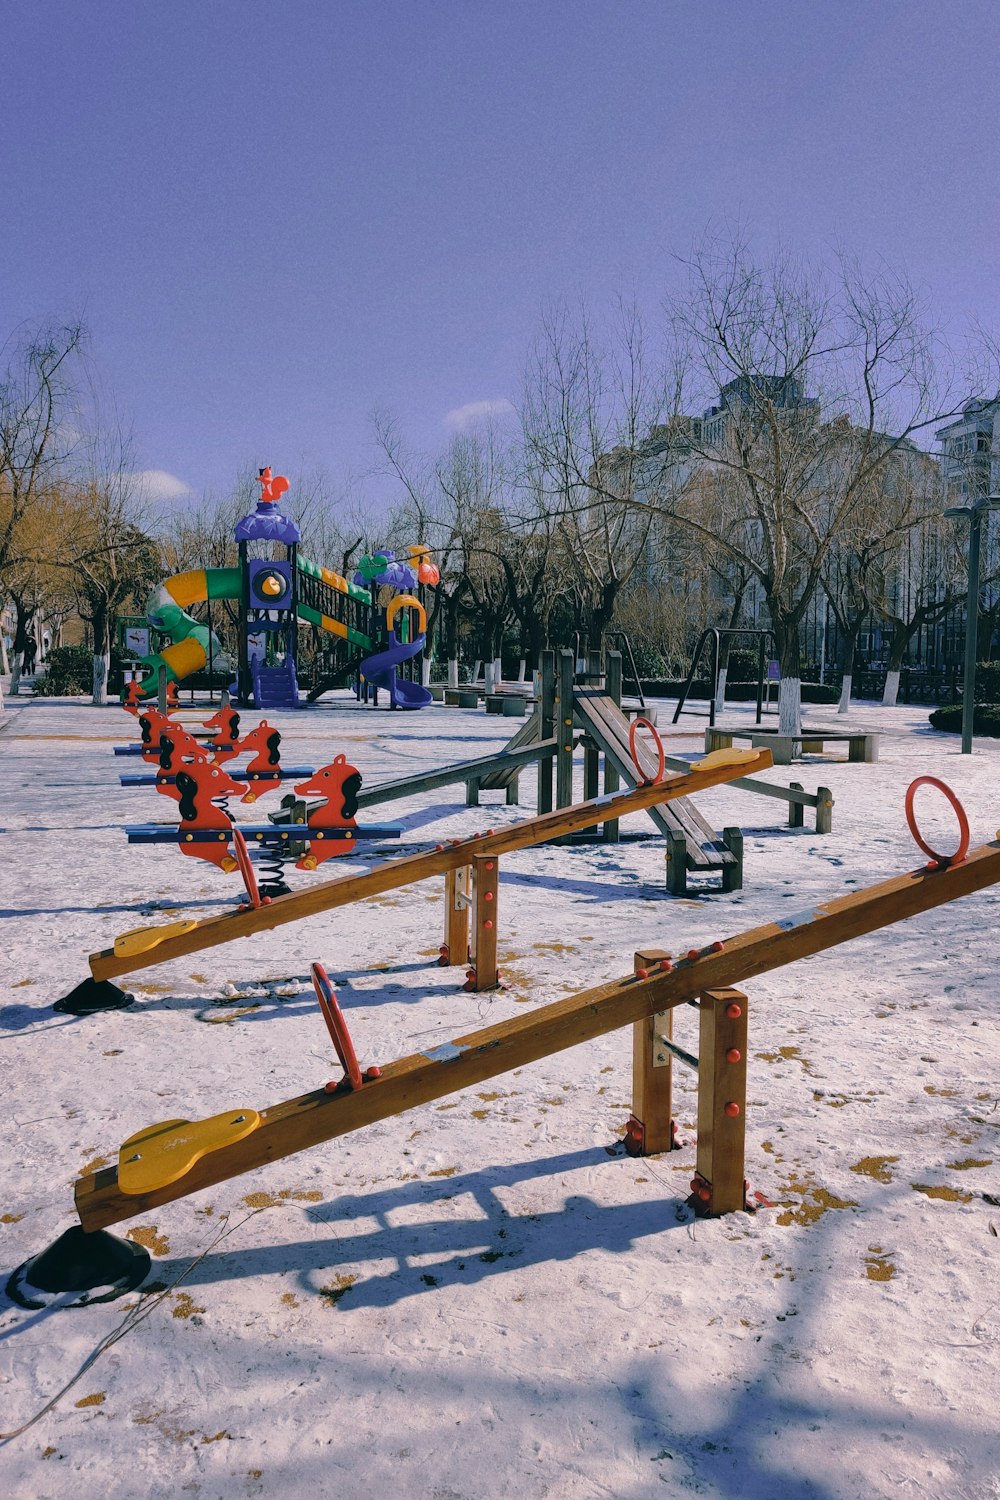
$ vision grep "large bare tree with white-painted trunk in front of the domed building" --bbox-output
[650,237,955,734]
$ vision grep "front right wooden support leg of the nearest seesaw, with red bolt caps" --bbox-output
[694,990,747,1215]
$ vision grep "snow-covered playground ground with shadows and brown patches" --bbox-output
[0,696,1000,1500]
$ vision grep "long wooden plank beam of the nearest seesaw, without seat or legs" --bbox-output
[76,834,1000,1230]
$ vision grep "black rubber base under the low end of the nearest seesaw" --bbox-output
[4,1224,150,1310]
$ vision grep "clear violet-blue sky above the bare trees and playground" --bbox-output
[0,0,1000,507]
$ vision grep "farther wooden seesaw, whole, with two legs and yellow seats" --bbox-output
[55,749,771,1014]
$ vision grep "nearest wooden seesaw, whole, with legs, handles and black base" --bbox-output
[7,777,1000,1307]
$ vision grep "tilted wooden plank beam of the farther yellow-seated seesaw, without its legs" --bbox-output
[90,750,771,980]
